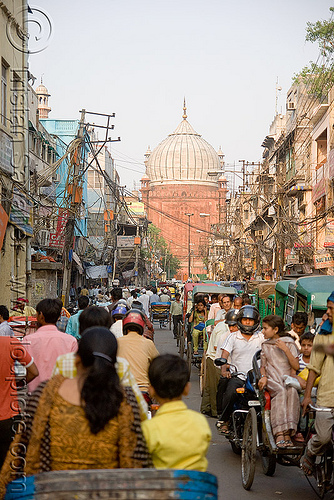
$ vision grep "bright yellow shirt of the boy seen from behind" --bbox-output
[142,401,211,472]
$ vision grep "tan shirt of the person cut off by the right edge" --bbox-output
[307,335,334,408]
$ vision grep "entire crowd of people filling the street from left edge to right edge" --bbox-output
[0,287,334,496]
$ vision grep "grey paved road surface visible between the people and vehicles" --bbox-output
[155,327,317,500]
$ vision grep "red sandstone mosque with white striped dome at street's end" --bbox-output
[141,103,227,280]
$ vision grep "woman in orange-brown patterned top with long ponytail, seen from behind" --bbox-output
[0,327,151,498]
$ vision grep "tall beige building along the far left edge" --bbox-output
[0,0,33,307]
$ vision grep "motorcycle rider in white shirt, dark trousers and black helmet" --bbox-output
[217,305,264,433]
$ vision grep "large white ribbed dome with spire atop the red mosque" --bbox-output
[146,102,221,185]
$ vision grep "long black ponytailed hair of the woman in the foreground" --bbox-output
[78,327,124,434]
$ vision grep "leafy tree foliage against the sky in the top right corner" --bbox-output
[293,7,334,101]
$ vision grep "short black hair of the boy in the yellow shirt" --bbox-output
[148,354,190,399]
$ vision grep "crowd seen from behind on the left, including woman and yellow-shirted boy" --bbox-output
[0,288,211,497]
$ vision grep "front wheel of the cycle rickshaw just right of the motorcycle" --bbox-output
[241,408,257,490]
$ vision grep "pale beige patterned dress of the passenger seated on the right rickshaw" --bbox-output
[261,336,300,435]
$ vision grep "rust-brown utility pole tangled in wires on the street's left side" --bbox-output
[62,109,85,306]
